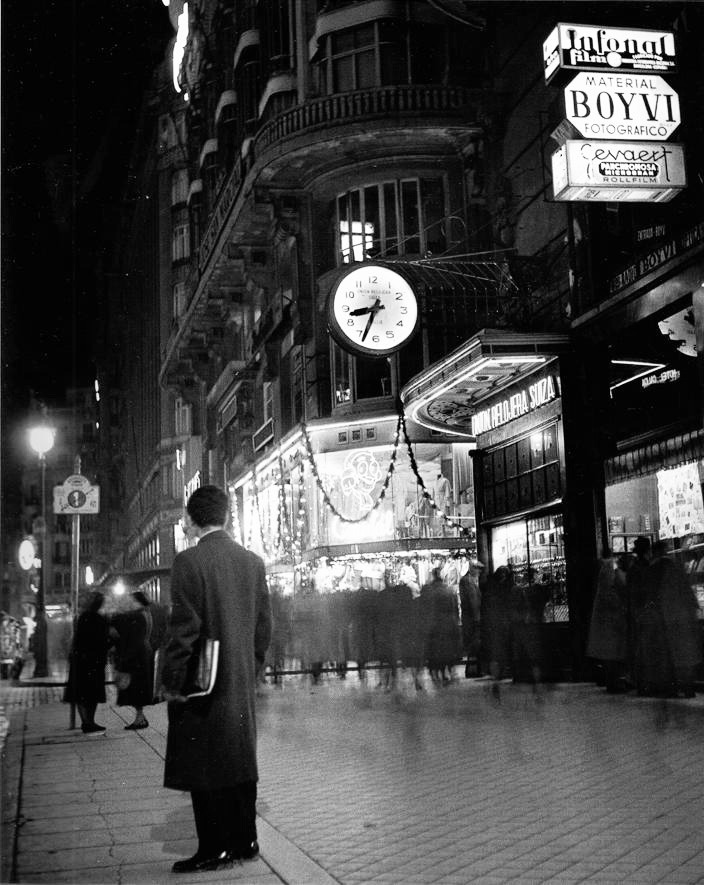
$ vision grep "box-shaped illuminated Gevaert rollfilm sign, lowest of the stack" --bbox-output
[552,139,687,203]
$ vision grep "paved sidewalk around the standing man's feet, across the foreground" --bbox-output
[0,674,704,885]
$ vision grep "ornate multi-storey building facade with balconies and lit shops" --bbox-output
[103,0,702,675]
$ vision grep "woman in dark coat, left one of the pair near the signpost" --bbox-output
[64,590,110,734]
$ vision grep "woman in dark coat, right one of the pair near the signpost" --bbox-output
[112,590,154,731]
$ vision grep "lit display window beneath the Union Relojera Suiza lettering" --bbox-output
[491,513,569,623]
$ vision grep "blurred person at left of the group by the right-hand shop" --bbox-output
[587,550,628,694]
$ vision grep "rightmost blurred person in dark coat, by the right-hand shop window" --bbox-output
[649,541,702,698]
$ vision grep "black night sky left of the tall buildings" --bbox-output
[0,0,172,540]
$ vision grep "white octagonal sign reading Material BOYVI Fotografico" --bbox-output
[564,72,681,141]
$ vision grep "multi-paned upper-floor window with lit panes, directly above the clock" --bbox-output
[336,178,447,264]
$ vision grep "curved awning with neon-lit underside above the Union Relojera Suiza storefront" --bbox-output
[401,329,569,437]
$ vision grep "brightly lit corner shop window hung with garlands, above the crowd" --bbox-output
[241,443,476,562]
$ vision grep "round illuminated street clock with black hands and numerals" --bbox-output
[328,265,418,356]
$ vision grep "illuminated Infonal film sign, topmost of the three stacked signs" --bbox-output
[543,22,676,82]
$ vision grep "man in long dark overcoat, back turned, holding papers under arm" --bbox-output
[162,485,272,873]
